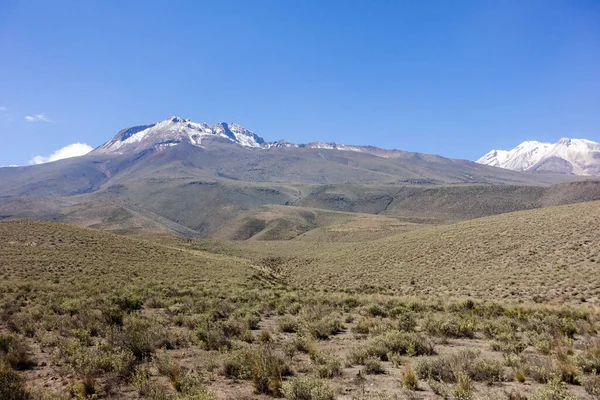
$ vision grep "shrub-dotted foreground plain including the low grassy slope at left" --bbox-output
[0,212,600,400]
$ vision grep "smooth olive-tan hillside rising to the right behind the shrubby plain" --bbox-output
[229,202,600,303]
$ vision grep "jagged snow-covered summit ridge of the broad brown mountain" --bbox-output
[94,117,363,154]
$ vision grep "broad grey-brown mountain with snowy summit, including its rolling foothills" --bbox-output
[0,117,600,239]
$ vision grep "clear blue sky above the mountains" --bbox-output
[0,0,600,165]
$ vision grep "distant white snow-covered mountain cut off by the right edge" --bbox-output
[477,138,600,176]
